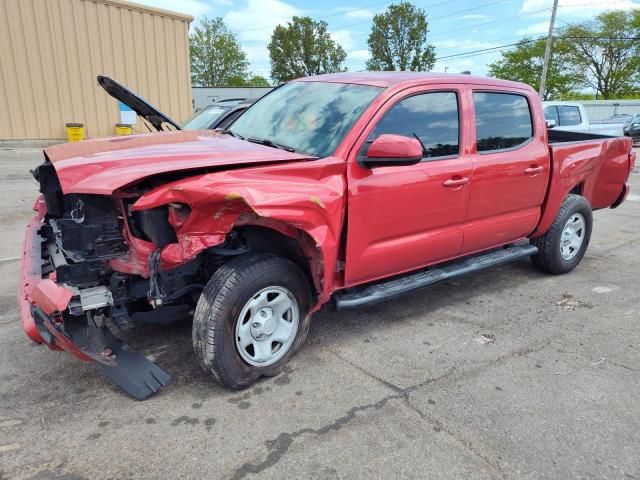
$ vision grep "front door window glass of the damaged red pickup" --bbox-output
[368,91,460,160]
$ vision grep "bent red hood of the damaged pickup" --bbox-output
[44,130,314,195]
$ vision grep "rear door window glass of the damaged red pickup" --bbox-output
[473,91,533,153]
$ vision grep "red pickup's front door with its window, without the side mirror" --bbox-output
[345,87,472,286]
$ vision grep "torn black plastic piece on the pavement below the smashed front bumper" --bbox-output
[100,338,171,400]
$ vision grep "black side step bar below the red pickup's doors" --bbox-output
[333,244,538,310]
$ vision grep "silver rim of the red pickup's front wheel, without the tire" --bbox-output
[236,287,300,367]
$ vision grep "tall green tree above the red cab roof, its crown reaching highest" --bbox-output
[367,2,436,71]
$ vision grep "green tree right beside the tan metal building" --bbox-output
[189,17,249,87]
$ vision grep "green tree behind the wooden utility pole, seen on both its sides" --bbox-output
[489,38,585,100]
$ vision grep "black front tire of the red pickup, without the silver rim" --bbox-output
[192,254,311,389]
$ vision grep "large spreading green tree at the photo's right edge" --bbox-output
[562,10,640,99]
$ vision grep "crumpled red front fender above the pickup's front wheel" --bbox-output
[133,157,346,305]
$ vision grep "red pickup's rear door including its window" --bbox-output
[461,89,550,254]
